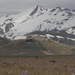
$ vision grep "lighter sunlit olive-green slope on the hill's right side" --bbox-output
[41,41,73,55]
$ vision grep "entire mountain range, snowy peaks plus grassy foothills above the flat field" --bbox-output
[0,5,75,56]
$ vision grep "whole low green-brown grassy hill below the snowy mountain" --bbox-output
[0,37,75,56]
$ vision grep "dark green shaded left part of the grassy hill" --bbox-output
[0,40,47,55]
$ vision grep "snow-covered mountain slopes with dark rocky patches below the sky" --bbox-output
[0,5,75,40]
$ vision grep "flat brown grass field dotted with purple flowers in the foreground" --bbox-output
[0,56,75,75]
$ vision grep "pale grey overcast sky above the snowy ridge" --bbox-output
[0,0,75,15]
